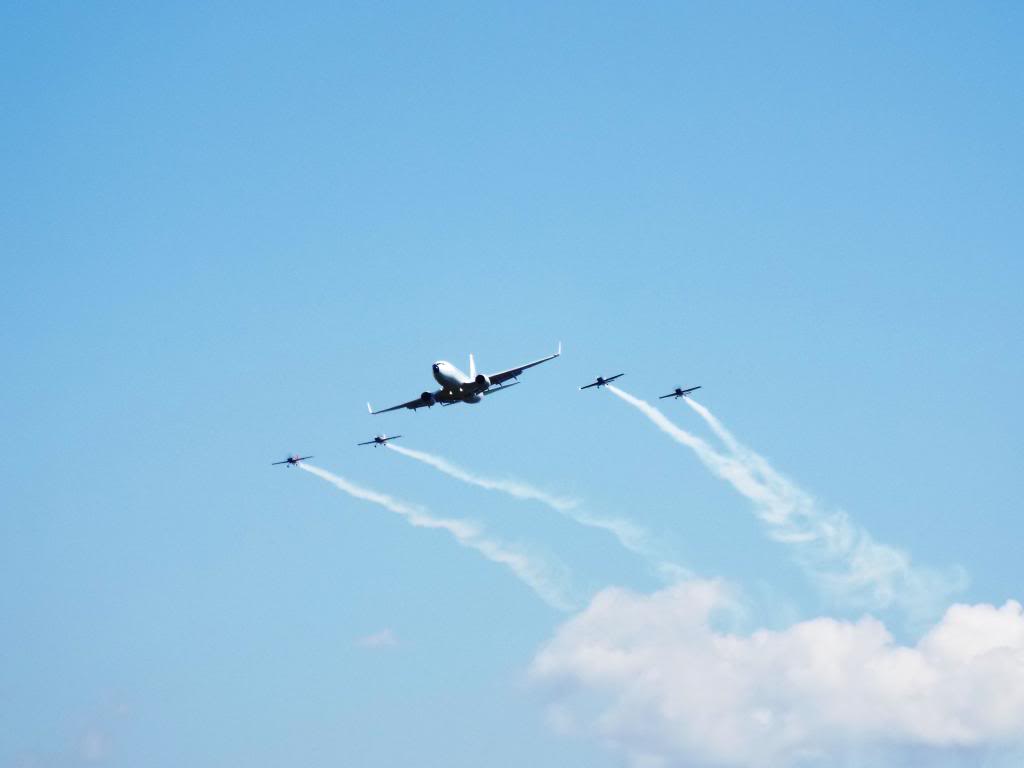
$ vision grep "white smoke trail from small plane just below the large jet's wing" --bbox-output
[386,443,692,581]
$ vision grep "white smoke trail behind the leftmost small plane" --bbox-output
[298,463,574,611]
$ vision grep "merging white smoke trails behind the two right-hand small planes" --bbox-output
[608,386,965,621]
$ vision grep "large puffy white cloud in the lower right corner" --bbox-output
[531,581,1024,768]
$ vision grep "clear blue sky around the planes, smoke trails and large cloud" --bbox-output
[0,2,1024,768]
